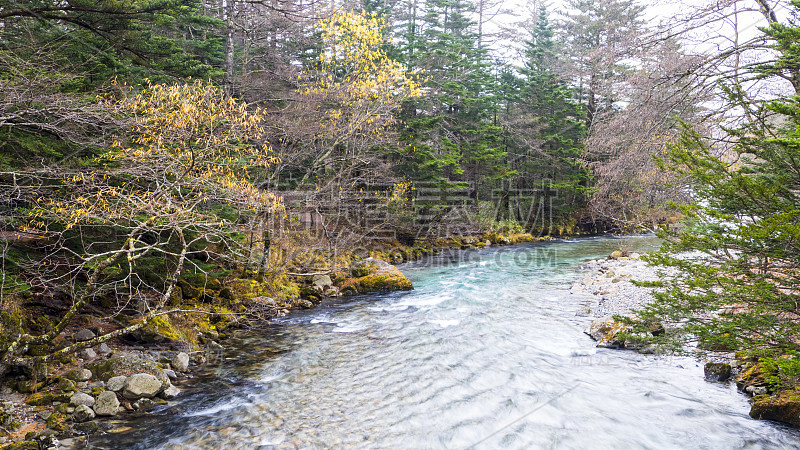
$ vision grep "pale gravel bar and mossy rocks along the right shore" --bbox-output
[570,251,800,426]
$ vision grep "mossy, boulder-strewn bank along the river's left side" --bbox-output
[0,233,547,449]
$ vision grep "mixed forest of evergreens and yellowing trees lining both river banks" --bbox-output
[0,0,800,442]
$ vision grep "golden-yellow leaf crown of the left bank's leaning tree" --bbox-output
[30,80,282,234]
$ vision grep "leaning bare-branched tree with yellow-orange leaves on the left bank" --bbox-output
[0,81,282,372]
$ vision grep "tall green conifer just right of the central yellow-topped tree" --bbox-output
[402,0,504,199]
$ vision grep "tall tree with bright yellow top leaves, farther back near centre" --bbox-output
[276,11,422,190]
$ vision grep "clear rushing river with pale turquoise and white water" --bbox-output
[94,237,800,449]
